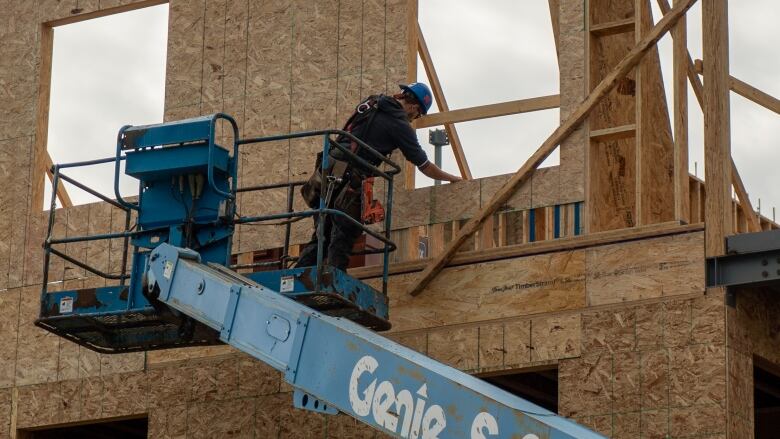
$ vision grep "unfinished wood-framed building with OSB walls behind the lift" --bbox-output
[0,0,780,438]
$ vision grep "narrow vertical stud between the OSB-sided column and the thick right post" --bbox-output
[662,0,691,223]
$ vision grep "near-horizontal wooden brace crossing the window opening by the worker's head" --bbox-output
[413,95,561,128]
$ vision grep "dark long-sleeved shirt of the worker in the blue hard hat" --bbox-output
[354,96,428,168]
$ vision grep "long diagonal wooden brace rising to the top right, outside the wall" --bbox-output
[409,0,696,296]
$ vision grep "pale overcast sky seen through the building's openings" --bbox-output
[49,0,780,222]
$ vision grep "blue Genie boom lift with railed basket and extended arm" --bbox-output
[36,114,602,439]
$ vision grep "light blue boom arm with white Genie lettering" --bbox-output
[147,244,603,439]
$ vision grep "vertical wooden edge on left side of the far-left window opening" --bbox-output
[30,24,54,212]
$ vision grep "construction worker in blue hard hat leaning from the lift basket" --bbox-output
[297,82,461,270]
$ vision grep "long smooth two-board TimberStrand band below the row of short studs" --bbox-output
[380,233,704,332]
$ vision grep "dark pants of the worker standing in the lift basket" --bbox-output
[295,192,363,270]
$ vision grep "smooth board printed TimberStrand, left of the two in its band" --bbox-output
[374,252,585,331]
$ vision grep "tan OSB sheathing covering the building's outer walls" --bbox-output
[0,0,756,438]
